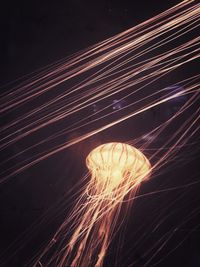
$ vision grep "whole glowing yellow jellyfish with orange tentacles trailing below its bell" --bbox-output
[36,142,151,267]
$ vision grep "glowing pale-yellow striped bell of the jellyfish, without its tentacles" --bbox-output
[86,143,151,196]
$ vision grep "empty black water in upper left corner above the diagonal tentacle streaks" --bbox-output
[1,0,183,82]
